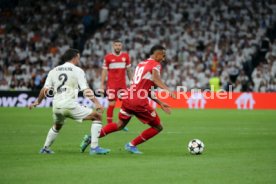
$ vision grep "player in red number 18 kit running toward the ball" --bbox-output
[81,45,175,154]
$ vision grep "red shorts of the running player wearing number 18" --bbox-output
[119,100,161,126]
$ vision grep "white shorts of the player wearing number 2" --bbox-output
[53,104,93,124]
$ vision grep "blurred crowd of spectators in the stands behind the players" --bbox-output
[0,0,276,92]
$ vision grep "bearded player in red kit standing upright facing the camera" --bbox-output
[100,40,133,123]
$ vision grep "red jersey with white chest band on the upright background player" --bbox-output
[103,52,131,89]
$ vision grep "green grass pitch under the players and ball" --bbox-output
[0,108,276,184]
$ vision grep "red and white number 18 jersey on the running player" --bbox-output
[128,59,161,102]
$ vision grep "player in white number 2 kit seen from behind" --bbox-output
[29,49,110,155]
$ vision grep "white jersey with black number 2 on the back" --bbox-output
[44,62,89,108]
